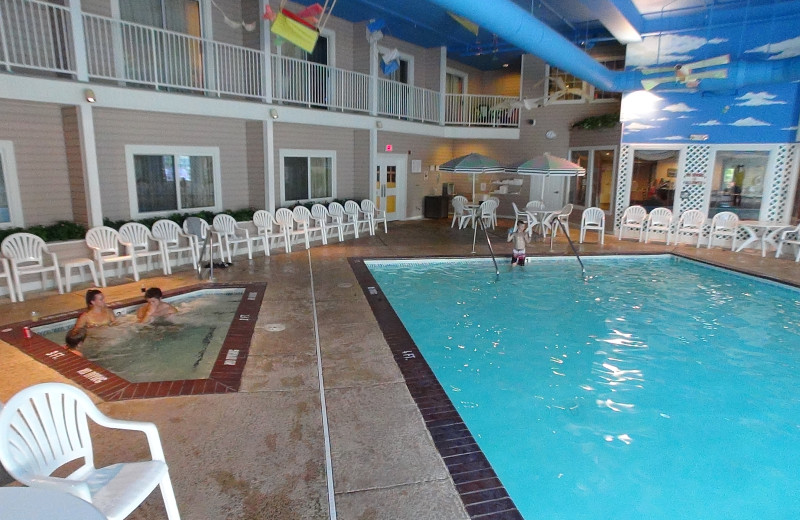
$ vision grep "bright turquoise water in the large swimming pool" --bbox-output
[367,256,800,520]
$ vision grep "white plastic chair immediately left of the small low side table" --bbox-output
[0,233,64,301]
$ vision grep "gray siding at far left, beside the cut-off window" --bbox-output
[0,100,73,226]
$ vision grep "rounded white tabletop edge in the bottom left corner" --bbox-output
[0,487,106,520]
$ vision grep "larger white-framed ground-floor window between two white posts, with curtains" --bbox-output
[125,146,222,218]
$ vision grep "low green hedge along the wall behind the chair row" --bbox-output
[0,199,356,242]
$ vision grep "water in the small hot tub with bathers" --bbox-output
[33,289,244,383]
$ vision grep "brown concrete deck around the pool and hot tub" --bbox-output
[0,220,800,520]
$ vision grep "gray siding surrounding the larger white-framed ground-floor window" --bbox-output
[94,109,250,219]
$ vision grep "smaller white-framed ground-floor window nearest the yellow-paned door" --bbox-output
[280,150,336,203]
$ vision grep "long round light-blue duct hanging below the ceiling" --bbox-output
[430,0,800,92]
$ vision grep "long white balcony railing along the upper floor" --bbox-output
[0,0,519,127]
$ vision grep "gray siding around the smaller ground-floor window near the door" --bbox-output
[274,123,356,206]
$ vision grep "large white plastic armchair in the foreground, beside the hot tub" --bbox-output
[0,383,180,520]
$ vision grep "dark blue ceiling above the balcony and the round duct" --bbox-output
[290,0,800,70]
